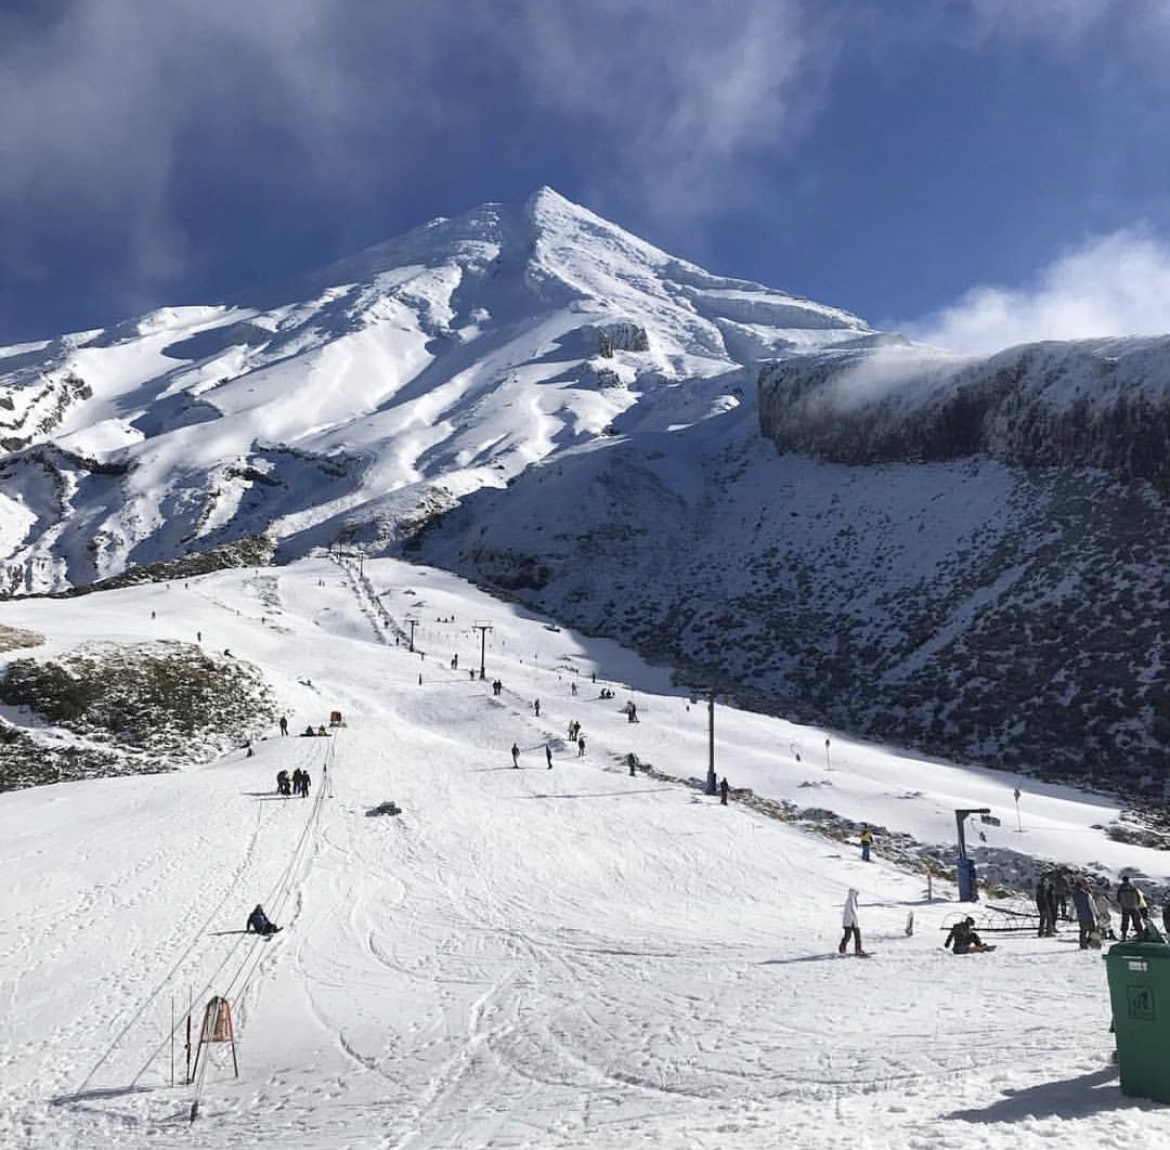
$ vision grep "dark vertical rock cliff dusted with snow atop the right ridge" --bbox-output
[759,337,1170,490]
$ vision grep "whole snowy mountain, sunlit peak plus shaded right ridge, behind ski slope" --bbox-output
[0,188,1170,794]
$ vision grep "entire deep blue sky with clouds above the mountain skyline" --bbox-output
[0,0,1170,350]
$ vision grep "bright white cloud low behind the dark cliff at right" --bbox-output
[903,229,1170,354]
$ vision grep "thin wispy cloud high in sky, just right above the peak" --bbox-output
[521,0,833,216]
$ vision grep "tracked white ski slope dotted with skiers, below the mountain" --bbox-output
[0,559,1170,1150]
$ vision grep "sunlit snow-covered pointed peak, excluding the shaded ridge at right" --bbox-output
[0,188,875,593]
